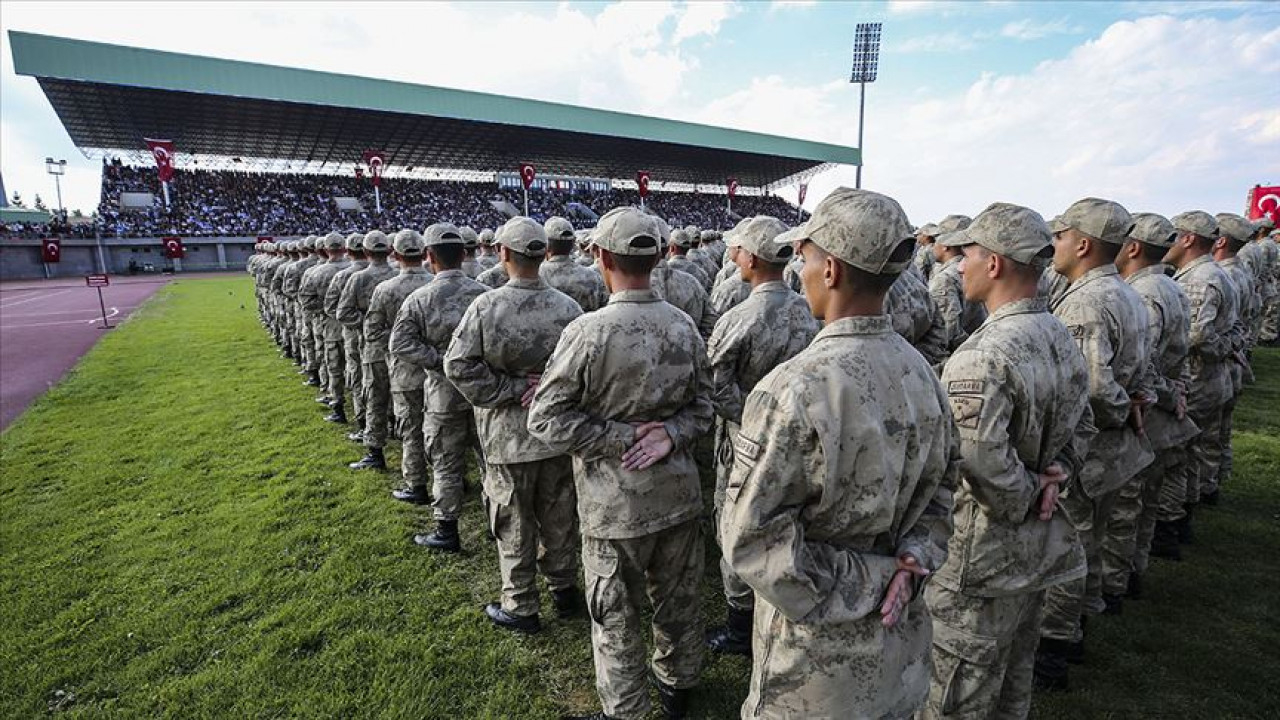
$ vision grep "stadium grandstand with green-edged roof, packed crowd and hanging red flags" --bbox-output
[0,31,860,277]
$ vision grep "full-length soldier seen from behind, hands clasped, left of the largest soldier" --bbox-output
[529,208,712,719]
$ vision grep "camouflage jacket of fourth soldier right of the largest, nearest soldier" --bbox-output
[1174,255,1235,415]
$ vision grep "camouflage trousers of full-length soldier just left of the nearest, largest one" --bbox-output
[582,519,704,719]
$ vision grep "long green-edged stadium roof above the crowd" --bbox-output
[9,31,861,187]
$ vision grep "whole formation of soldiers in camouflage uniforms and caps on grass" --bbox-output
[250,194,1280,717]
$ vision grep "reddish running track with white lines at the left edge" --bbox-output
[0,275,170,430]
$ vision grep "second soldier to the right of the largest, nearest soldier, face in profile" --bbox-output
[1036,197,1155,688]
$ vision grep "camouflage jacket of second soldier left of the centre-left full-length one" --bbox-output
[390,270,489,413]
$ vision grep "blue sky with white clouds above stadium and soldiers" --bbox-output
[0,0,1280,224]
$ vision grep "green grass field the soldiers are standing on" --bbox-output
[0,278,1280,719]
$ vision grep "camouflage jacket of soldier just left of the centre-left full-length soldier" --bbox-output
[444,278,582,464]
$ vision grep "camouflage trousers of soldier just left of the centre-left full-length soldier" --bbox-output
[484,455,577,618]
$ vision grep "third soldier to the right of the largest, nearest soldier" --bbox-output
[1102,213,1198,571]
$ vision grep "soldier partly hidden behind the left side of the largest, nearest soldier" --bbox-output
[707,215,818,656]
